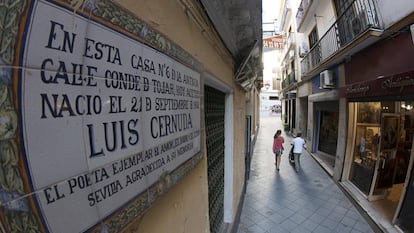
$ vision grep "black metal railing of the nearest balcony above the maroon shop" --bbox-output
[301,0,381,74]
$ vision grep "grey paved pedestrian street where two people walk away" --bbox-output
[237,114,374,233]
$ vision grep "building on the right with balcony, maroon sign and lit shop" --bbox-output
[282,0,414,232]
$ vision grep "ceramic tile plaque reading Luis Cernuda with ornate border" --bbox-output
[0,1,201,233]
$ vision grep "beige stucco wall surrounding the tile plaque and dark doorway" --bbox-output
[117,0,249,233]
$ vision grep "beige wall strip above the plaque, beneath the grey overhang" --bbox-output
[118,0,234,85]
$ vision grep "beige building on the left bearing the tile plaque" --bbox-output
[0,0,262,233]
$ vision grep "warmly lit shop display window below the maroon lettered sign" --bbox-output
[347,101,414,227]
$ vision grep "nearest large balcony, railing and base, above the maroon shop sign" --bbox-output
[301,0,382,76]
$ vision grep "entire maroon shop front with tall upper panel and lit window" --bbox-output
[339,27,414,232]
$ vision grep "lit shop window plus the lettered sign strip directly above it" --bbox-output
[341,71,414,232]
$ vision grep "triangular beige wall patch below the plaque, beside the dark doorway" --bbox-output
[132,159,210,233]
